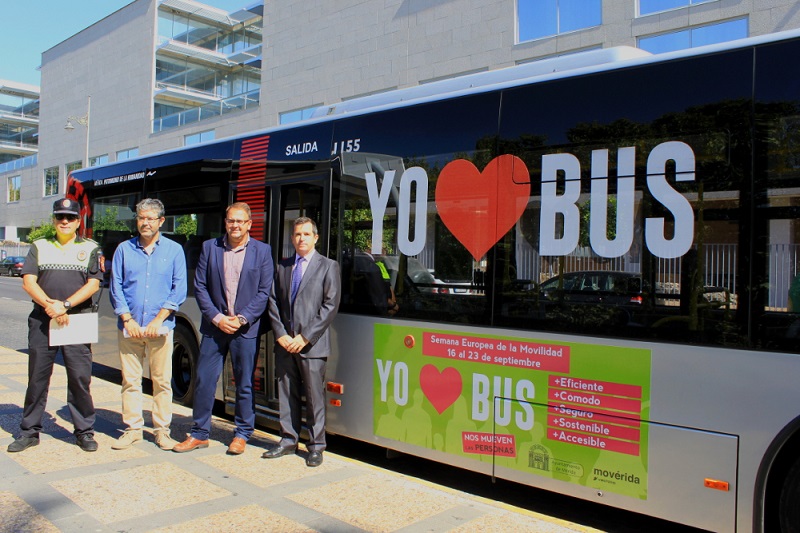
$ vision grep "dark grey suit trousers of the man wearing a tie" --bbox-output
[275,352,328,452]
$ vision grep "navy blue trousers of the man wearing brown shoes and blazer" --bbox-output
[192,331,259,440]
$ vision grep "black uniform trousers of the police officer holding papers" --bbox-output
[19,310,95,437]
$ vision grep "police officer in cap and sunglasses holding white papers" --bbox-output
[8,198,103,452]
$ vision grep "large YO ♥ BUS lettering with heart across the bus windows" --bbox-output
[364,141,695,261]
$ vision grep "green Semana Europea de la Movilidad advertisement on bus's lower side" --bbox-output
[374,324,650,499]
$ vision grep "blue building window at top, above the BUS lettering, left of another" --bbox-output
[517,0,602,42]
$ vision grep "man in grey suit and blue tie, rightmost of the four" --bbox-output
[262,217,341,466]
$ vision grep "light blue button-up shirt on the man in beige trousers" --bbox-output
[109,235,186,329]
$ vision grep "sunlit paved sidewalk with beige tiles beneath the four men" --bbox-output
[0,347,594,533]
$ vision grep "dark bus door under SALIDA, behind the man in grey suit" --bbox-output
[247,166,332,420]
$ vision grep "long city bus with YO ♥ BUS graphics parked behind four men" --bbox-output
[68,32,800,532]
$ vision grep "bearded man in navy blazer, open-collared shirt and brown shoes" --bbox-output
[173,202,274,455]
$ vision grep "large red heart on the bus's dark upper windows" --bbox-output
[436,155,531,261]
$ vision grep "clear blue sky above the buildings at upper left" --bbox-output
[0,0,255,86]
